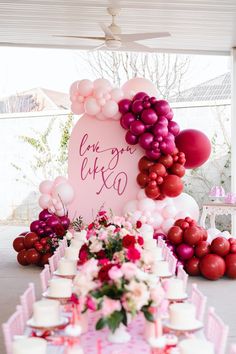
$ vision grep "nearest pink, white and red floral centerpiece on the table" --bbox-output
[74,259,164,342]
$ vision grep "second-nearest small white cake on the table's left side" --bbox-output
[33,299,61,326]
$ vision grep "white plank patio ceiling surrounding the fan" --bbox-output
[0,0,236,55]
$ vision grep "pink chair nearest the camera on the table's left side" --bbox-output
[2,306,24,354]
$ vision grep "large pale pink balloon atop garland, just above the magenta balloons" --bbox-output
[122,77,158,97]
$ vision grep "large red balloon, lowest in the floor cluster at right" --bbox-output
[199,253,225,280]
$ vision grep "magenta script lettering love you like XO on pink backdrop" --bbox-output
[79,134,136,195]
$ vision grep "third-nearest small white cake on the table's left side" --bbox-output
[48,278,72,298]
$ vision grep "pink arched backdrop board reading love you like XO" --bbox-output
[68,115,143,222]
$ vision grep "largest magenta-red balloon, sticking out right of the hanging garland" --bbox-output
[175,129,211,168]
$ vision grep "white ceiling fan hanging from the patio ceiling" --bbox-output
[56,7,170,51]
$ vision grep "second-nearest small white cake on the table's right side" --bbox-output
[169,303,198,329]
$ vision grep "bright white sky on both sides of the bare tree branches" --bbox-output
[0,47,230,97]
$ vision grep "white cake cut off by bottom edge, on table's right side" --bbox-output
[178,338,214,354]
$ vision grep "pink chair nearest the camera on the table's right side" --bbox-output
[204,307,229,354]
